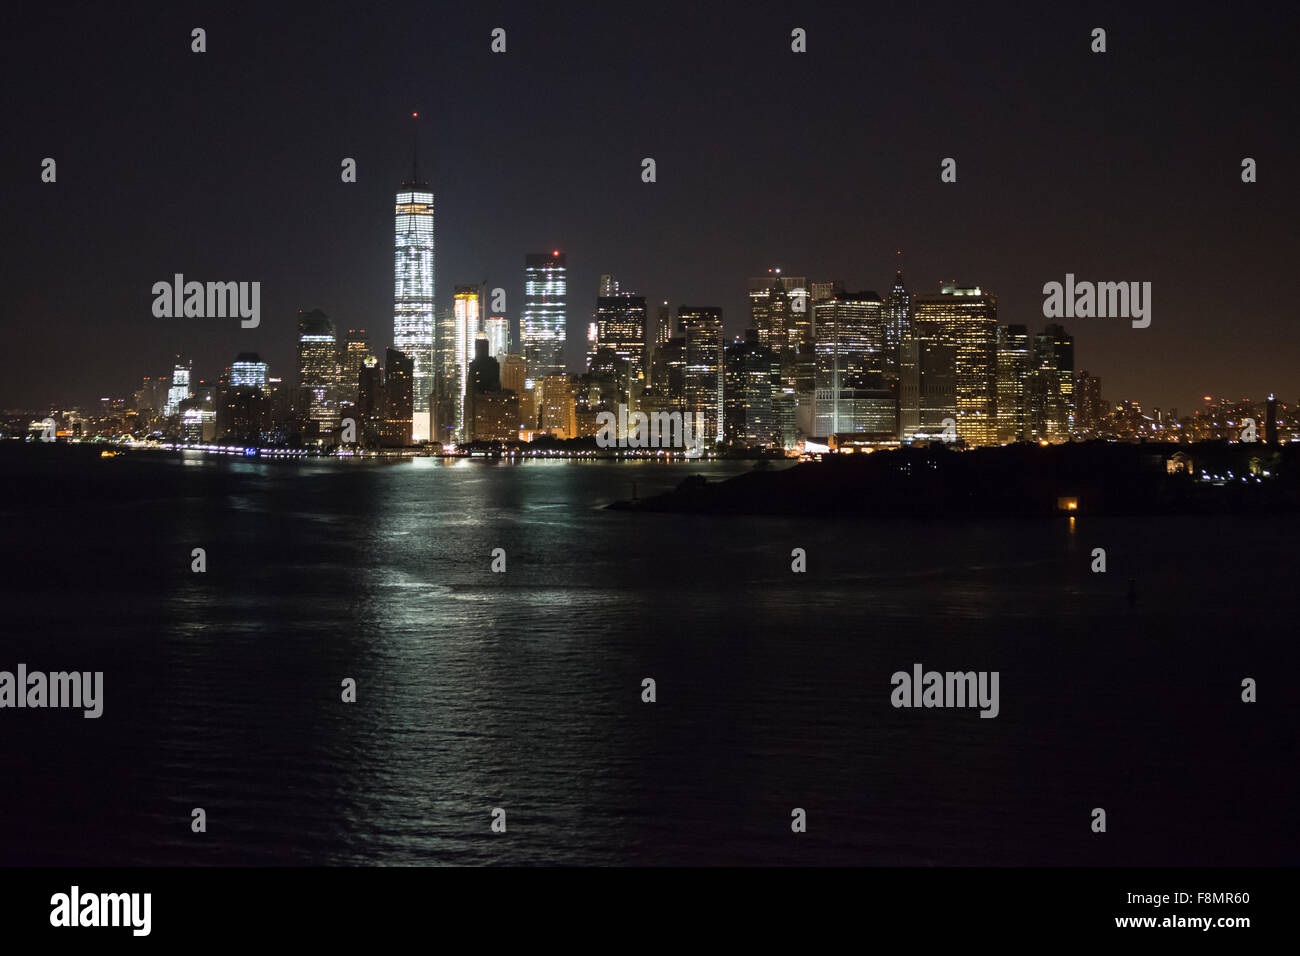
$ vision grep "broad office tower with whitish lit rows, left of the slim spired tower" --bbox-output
[813,291,898,437]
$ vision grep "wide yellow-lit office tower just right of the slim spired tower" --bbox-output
[911,285,997,445]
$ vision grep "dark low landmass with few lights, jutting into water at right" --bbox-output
[608,441,1300,515]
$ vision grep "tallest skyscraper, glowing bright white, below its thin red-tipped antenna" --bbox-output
[393,163,436,442]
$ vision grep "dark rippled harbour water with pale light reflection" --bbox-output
[0,446,1300,865]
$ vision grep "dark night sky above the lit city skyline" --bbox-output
[0,3,1300,414]
